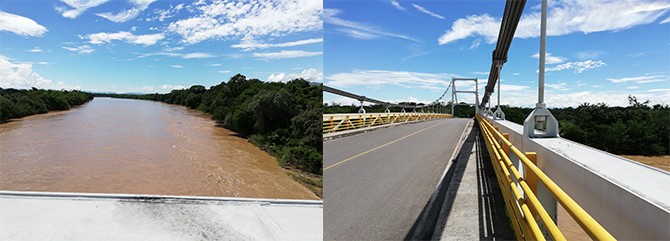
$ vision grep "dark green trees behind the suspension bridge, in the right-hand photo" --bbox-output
[324,96,670,156]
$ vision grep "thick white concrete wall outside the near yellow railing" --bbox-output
[492,116,670,240]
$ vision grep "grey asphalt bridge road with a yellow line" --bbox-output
[323,119,468,240]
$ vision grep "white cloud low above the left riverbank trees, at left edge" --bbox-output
[0,55,81,89]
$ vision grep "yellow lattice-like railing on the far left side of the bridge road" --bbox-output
[323,113,452,133]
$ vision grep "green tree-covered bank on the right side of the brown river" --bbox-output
[95,74,323,175]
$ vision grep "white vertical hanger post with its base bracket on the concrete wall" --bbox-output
[523,0,558,138]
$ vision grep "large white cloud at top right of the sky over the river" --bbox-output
[167,0,323,44]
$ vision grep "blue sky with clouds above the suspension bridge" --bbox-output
[323,0,670,107]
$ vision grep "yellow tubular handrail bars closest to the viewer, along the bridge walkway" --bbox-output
[477,115,615,240]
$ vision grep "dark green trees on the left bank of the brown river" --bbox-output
[0,88,93,123]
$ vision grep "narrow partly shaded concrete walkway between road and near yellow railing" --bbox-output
[432,124,515,240]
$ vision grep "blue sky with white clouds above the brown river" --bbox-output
[0,0,323,92]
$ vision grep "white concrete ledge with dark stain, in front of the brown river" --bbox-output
[0,191,323,240]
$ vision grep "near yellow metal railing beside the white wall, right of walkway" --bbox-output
[477,115,615,240]
